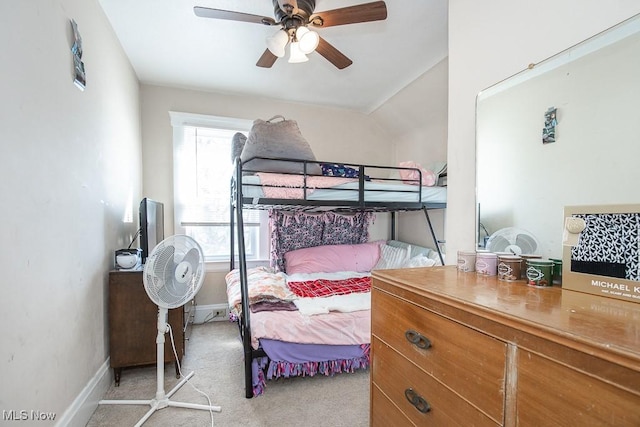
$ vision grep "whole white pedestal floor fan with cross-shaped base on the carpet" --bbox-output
[98,235,221,427]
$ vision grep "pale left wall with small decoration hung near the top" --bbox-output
[0,0,141,425]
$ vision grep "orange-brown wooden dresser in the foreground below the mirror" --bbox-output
[370,266,640,427]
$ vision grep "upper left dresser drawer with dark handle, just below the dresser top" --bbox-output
[371,288,507,423]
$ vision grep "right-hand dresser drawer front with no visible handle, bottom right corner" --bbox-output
[516,350,640,427]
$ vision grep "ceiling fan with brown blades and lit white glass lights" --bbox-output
[193,0,387,69]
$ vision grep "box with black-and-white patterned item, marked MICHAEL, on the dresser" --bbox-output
[562,205,640,303]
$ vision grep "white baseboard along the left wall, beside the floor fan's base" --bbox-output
[56,358,113,427]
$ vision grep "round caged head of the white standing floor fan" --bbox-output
[143,235,205,309]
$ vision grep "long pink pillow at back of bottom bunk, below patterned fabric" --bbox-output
[284,242,380,274]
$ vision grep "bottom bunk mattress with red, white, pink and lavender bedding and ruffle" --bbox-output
[227,267,371,396]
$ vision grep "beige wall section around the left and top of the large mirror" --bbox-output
[446,0,640,263]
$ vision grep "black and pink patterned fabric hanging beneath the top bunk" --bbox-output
[269,210,374,271]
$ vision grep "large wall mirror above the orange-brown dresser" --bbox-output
[476,15,640,258]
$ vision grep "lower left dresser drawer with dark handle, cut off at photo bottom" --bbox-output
[371,337,498,426]
